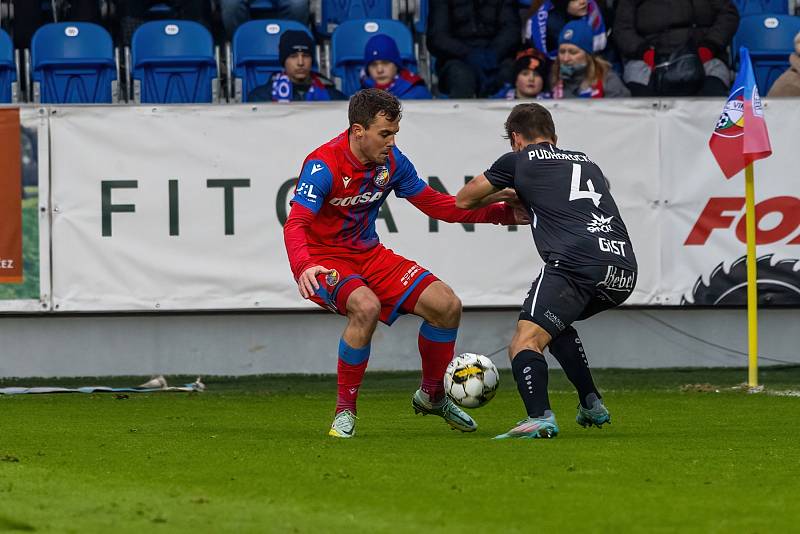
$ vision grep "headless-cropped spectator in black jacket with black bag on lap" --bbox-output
[614,0,739,96]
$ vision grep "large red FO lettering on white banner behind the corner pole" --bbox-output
[683,196,800,245]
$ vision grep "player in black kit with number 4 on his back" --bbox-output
[456,103,637,439]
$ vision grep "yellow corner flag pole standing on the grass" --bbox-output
[744,163,758,388]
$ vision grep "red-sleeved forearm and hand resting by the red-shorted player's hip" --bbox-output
[283,203,331,299]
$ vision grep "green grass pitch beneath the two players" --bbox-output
[0,367,800,533]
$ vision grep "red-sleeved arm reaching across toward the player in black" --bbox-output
[408,186,530,225]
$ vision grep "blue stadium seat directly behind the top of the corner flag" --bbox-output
[734,15,800,95]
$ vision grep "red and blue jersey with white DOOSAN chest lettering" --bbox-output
[291,131,427,255]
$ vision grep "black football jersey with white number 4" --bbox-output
[485,143,636,270]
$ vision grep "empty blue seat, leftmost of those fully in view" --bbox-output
[31,22,117,104]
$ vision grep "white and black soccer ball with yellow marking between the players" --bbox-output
[444,352,500,408]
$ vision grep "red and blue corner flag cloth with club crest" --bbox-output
[708,47,772,178]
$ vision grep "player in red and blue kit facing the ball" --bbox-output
[284,89,529,438]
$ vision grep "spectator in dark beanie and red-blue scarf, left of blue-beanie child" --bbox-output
[247,30,347,102]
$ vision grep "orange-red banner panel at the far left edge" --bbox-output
[0,108,22,284]
